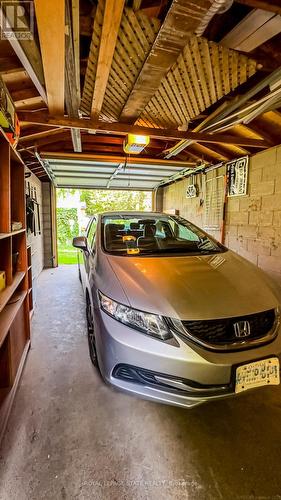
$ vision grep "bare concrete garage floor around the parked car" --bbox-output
[0,266,281,500]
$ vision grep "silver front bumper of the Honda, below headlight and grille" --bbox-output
[95,309,281,408]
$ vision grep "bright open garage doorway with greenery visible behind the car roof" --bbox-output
[57,188,152,265]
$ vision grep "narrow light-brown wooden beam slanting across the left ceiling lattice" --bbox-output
[91,0,125,117]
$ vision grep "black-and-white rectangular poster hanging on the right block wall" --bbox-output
[226,156,248,196]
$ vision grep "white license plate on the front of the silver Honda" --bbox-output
[235,358,280,393]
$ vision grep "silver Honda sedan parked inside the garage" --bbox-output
[73,212,281,407]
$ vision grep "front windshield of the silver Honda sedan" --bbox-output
[102,214,226,256]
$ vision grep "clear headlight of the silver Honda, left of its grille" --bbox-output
[99,292,173,340]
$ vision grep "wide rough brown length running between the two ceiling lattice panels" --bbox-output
[121,0,214,122]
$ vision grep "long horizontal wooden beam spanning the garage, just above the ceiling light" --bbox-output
[18,112,268,149]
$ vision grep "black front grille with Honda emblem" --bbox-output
[179,309,276,348]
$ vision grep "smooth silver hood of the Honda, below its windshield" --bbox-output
[108,250,279,320]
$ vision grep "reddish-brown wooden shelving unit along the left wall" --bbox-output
[0,130,30,440]
